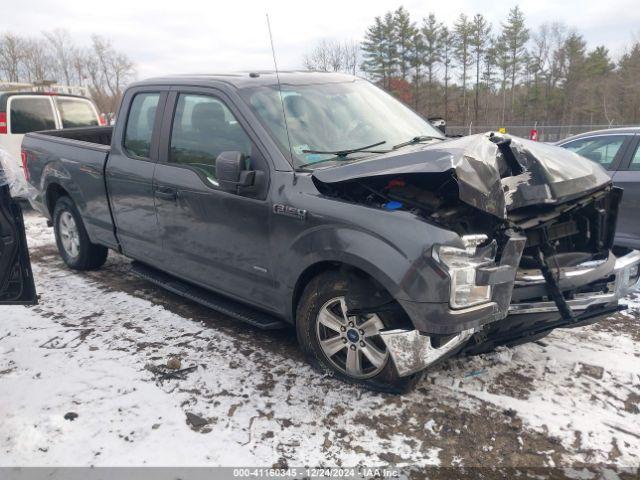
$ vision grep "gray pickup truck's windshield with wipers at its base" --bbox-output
[240,80,444,168]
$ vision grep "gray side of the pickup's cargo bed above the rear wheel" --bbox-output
[22,127,117,248]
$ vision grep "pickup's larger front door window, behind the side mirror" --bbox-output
[169,94,251,186]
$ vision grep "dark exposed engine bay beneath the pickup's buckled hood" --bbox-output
[320,172,621,268]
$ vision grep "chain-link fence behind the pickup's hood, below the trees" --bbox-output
[447,124,638,142]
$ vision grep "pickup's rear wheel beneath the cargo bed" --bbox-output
[53,197,109,270]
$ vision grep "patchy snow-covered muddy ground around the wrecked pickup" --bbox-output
[0,212,640,467]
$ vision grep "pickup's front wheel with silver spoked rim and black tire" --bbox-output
[296,271,422,393]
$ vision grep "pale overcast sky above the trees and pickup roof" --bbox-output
[0,0,640,79]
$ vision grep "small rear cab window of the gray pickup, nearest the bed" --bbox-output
[124,93,160,158]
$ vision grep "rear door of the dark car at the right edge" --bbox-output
[613,135,640,248]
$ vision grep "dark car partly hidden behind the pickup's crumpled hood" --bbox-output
[556,127,640,248]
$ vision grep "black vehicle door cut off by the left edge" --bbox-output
[0,180,37,305]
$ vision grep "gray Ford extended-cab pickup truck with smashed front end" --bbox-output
[22,72,640,392]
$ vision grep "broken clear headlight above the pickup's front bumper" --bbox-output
[433,235,496,308]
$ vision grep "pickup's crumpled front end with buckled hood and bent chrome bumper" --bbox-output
[313,133,638,375]
